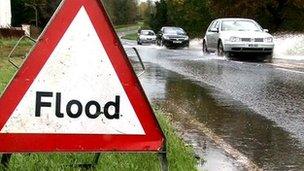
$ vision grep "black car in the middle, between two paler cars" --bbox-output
[156,27,189,47]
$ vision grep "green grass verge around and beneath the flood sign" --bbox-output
[0,39,196,171]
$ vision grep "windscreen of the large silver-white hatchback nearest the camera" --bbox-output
[221,20,262,31]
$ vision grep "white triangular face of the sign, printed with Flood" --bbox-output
[1,7,145,135]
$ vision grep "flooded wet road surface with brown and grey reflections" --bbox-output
[123,35,304,170]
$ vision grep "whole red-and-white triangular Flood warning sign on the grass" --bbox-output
[0,0,164,152]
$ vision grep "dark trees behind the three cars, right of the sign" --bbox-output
[145,0,304,37]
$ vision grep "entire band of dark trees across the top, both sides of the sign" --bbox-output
[11,0,304,37]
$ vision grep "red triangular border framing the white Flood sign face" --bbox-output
[0,0,165,153]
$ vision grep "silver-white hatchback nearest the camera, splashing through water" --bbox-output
[203,18,274,58]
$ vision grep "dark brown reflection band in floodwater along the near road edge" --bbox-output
[141,64,304,170]
